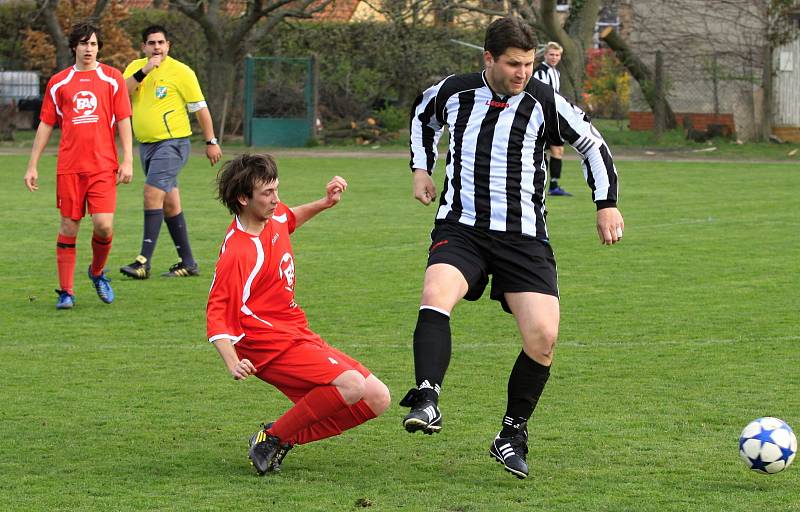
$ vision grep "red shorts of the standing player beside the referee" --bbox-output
[56,171,117,220]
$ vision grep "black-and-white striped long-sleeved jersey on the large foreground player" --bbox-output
[410,73,617,240]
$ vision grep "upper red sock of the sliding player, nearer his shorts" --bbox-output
[267,386,349,442]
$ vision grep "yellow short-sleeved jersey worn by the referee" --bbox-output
[122,56,205,142]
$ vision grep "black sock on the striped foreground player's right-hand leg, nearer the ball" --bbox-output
[500,350,550,437]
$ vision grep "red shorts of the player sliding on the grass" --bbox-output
[234,331,372,402]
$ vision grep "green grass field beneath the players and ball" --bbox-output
[0,150,800,512]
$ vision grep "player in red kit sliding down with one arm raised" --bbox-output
[206,155,390,475]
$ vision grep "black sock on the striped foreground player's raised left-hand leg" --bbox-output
[414,308,451,403]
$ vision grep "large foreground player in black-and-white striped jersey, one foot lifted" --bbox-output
[400,17,624,478]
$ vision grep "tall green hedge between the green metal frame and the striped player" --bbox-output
[252,23,482,119]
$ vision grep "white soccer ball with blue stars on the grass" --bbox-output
[739,417,797,474]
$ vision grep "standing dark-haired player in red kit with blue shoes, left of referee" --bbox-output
[24,23,133,309]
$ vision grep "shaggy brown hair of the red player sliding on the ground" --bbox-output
[217,153,278,215]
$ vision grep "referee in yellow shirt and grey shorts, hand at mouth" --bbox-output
[120,25,222,279]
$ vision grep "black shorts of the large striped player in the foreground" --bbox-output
[428,222,558,313]
